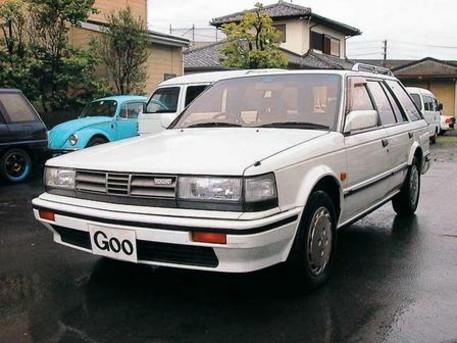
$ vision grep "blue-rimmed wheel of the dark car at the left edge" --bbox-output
[0,149,32,182]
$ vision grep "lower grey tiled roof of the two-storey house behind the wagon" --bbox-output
[184,41,354,72]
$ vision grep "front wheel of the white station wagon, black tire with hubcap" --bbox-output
[286,191,336,292]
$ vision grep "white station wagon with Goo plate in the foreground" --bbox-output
[33,66,430,289]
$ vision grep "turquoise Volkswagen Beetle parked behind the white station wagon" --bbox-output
[49,95,147,154]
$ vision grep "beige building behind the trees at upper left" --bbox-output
[70,0,190,93]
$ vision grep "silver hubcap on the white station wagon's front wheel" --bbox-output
[307,207,332,276]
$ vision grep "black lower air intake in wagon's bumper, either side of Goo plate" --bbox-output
[52,225,219,268]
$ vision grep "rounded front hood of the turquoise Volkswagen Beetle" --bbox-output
[49,117,113,149]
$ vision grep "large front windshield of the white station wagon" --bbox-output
[170,73,341,130]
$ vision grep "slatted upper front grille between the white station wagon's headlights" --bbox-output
[76,171,177,199]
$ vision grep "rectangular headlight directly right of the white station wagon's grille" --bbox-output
[178,176,242,202]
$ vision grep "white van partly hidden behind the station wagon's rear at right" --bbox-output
[406,87,443,142]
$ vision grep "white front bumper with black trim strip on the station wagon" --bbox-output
[32,193,302,272]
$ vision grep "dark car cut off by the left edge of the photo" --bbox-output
[0,89,48,182]
